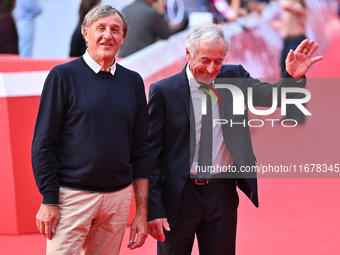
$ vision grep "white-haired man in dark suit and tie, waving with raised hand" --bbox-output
[148,24,322,255]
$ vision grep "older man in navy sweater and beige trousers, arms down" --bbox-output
[32,5,148,254]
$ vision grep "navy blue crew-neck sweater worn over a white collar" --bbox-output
[32,57,148,204]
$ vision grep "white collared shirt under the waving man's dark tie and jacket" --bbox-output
[186,63,234,174]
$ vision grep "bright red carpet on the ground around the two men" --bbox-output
[0,37,340,255]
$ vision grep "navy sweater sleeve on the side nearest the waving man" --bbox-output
[131,75,149,180]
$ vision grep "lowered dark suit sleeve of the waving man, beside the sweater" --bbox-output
[148,84,166,221]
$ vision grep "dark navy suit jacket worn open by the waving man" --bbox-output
[148,65,305,224]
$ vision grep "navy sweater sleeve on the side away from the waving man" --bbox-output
[31,70,65,204]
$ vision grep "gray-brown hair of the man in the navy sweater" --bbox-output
[81,5,129,38]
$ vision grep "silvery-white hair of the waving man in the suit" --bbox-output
[185,24,230,57]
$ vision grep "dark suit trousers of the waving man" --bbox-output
[157,179,239,255]
